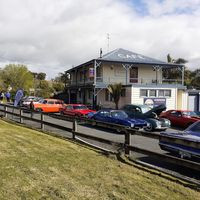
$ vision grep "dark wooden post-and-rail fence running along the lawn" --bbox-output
[0,104,200,175]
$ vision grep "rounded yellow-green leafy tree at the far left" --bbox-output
[0,64,33,91]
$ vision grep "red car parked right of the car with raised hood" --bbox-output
[160,110,200,128]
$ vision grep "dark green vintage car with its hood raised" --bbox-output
[122,104,171,131]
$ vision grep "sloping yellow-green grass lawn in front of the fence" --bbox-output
[0,120,200,200]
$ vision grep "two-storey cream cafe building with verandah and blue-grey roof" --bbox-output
[67,49,188,109]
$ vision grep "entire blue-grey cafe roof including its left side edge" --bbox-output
[68,48,183,71]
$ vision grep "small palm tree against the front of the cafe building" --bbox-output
[108,83,122,109]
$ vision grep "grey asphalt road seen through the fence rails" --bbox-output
[0,107,200,180]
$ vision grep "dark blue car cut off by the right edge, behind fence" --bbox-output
[159,121,200,158]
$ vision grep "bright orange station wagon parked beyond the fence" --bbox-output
[33,99,64,112]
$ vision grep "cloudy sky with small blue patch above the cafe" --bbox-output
[0,0,200,79]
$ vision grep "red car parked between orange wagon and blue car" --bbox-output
[60,104,96,117]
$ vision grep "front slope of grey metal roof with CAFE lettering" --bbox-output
[98,48,168,65]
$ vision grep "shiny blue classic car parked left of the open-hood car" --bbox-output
[88,109,148,132]
